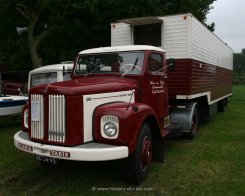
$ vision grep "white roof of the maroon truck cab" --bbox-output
[79,45,165,54]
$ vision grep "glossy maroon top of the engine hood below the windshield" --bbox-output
[30,76,139,96]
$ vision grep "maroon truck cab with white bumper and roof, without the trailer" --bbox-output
[14,45,198,183]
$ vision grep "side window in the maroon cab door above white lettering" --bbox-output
[148,54,163,73]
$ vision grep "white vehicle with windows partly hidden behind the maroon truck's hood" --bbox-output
[28,61,73,91]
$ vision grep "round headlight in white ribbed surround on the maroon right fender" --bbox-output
[100,115,119,139]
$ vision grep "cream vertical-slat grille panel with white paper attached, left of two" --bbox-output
[31,94,44,139]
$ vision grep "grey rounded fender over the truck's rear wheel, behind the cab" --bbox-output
[171,102,198,133]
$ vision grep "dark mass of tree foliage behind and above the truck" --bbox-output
[0,0,218,69]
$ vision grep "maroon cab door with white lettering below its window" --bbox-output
[143,52,169,119]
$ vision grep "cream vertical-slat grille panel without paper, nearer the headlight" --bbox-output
[48,95,66,143]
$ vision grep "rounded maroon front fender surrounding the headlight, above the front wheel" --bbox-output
[93,102,156,154]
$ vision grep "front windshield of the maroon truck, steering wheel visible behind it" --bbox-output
[75,51,144,75]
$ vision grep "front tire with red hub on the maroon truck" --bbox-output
[127,123,152,185]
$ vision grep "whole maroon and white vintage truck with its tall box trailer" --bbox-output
[14,14,232,184]
